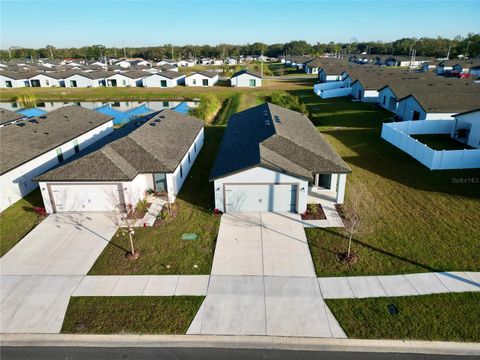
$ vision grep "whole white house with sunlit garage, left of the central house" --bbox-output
[35,110,204,213]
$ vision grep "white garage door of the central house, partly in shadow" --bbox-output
[225,184,297,212]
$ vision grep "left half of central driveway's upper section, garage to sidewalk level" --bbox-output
[212,213,263,275]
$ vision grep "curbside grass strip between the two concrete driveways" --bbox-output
[61,296,204,334]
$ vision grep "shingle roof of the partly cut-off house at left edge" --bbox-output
[0,106,113,174]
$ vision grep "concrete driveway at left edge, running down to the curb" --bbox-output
[0,213,116,333]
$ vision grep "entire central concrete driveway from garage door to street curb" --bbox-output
[188,213,345,337]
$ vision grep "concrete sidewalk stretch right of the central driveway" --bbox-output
[318,272,480,299]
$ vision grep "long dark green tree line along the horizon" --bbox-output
[0,33,480,60]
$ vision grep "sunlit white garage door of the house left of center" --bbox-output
[51,184,122,212]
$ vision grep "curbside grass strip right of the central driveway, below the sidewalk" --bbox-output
[325,293,480,342]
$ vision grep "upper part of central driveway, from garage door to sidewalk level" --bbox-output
[212,213,315,276]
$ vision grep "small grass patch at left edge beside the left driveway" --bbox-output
[0,189,43,256]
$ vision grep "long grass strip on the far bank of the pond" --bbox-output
[0,78,314,101]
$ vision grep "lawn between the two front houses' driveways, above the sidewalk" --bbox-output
[89,126,224,275]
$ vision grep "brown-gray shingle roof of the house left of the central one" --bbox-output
[35,109,203,181]
